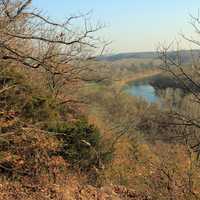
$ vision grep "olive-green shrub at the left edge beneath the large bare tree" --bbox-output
[0,68,60,123]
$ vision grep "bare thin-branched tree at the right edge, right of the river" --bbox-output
[159,13,200,157]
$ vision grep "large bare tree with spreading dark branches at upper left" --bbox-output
[0,0,108,95]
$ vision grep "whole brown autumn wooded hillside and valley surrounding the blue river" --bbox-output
[0,0,200,200]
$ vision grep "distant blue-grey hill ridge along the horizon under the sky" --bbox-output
[97,50,200,63]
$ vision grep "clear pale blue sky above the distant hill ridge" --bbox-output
[33,0,200,53]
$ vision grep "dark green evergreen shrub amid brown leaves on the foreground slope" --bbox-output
[48,119,112,170]
